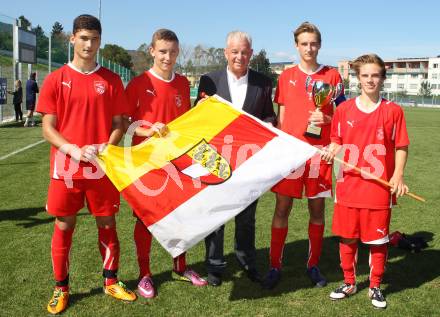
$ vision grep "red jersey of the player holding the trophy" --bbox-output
[274,65,343,145]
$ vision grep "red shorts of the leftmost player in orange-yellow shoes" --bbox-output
[46,176,120,217]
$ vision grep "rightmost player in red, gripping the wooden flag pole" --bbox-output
[323,54,409,308]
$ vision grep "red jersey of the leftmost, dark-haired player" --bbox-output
[37,64,126,179]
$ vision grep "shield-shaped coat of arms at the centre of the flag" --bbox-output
[171,139,232,185]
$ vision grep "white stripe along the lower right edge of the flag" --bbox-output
[148,131,317,257]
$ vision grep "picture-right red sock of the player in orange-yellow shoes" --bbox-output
[98,227,119,286]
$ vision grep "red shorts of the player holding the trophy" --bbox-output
[272,156,332,199]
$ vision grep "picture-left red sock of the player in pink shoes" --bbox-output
[134,220,152,278]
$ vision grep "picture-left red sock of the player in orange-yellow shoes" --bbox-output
[51,224,74,291]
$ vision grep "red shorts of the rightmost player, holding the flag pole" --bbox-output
[332,203,391,244]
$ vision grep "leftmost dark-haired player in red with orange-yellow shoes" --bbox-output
[37,15,136,314]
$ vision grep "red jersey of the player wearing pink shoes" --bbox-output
[126,70,191,145]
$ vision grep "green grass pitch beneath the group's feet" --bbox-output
[0,108,440,316]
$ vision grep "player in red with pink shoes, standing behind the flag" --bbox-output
[126,29,207,298]
